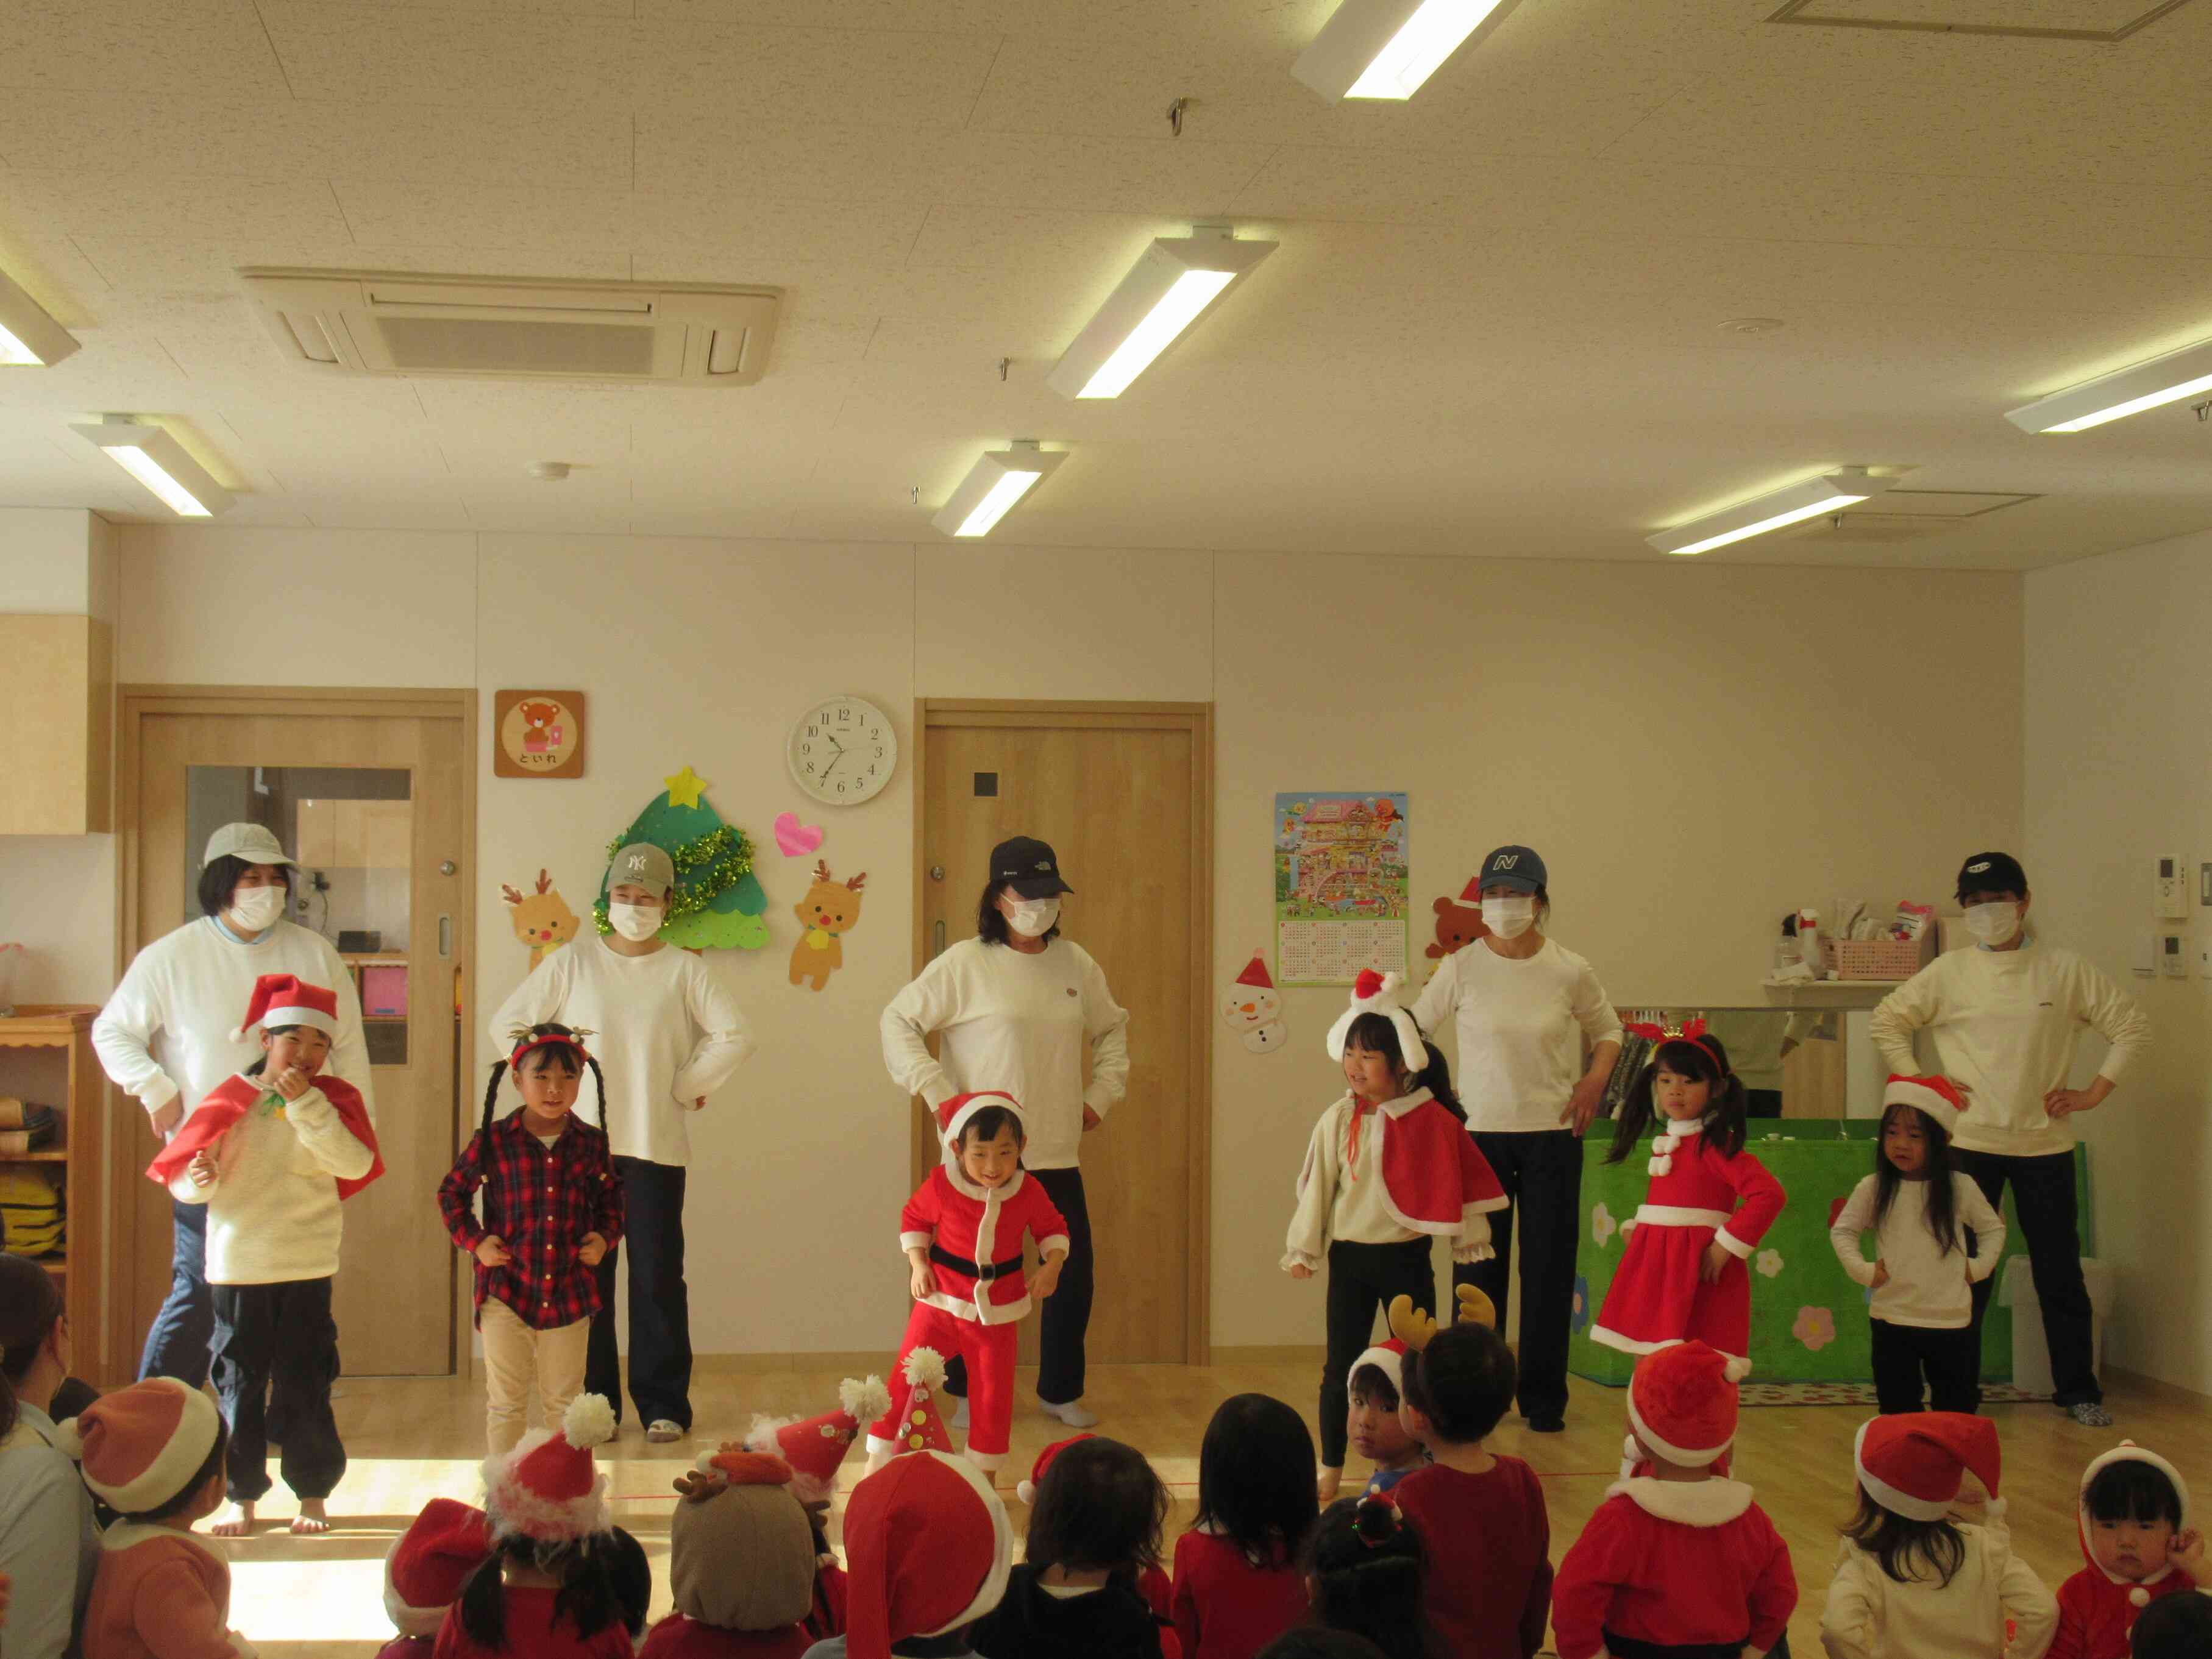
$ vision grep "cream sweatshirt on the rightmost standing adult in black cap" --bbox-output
[1867,940,2150,1157]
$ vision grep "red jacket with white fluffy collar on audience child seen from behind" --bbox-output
[1551,1480,1796,1659]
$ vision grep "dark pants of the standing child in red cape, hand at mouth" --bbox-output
[210,1279,345,1504]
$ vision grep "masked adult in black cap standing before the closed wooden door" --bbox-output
[880,836,1128,1429]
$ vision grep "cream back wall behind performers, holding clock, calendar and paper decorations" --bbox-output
[0,528,2022,1352]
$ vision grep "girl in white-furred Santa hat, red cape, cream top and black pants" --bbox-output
[1281,969,1506,1502]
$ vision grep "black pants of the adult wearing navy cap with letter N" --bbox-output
[1451,1128,1582,1423]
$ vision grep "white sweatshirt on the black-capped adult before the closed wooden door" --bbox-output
[878,938,1128,1170]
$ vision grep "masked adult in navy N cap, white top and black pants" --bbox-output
[1414,847,1621,1433]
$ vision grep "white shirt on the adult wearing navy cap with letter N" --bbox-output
[1414,940,1621,1135]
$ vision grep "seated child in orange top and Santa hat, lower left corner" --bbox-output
[62,1376,254,1659]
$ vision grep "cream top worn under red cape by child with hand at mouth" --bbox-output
[168,1089,376,1285]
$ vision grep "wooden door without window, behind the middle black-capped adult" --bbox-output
[914,703,1214,1365]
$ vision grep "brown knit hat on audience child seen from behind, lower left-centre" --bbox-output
[668,1447,814,1630]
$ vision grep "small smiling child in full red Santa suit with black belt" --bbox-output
[867,1090,1069,1469]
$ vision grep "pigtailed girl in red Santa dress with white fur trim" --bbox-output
[1590,1020,1787,1380]
